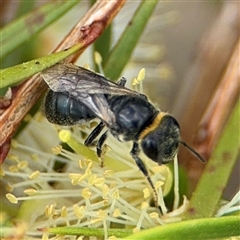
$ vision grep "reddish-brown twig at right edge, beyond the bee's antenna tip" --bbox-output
[194,40,240,159]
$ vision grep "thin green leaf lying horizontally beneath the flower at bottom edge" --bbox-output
[46,227,132,238]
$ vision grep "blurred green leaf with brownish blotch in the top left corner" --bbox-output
[0,0,79,58]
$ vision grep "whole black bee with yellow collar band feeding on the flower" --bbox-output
[42,64,205,211]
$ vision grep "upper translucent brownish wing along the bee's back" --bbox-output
[42,63,140,95]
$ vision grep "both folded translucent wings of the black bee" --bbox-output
[42,64,139,126]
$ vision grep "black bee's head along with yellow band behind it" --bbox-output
[140,113,180,165]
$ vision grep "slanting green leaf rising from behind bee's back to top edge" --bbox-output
[103,0,158,79]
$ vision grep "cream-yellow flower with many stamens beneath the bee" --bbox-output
[1,113,182,239]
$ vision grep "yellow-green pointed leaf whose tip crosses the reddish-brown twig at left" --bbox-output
[0,44,82,88]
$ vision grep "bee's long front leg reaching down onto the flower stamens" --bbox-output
[130,142,163,214]
